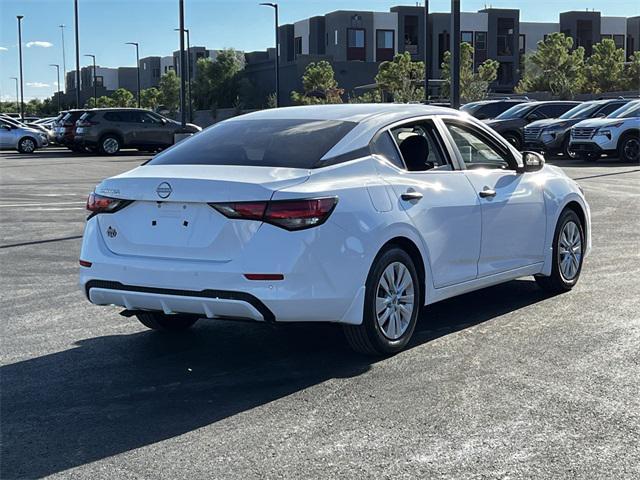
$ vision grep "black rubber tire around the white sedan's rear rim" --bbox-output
[343,247,422,356]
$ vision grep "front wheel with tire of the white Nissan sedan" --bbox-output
[535,210,585,293]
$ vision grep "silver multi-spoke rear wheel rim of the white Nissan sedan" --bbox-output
[376,262,415,340]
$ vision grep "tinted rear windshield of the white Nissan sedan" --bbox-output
[147,119,356,168]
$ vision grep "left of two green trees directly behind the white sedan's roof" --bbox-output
[291,60,344,105]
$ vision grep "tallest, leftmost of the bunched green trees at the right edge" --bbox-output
[516,32,585,99]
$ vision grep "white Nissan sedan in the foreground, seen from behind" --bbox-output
[80,104,591,354]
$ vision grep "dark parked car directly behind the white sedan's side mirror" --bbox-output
[484,101,580,150]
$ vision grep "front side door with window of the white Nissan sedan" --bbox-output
[443,118,546,277]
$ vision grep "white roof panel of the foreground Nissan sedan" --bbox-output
[227,103,466,123]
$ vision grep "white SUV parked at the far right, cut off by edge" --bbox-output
[569,100,640,162]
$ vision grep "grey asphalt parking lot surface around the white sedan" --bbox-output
[0,149,640,479]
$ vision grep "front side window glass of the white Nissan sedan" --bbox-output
[445,121,509,170]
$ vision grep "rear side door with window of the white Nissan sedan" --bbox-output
[373,120,481,288]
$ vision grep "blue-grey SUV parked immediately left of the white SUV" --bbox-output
[524,99,629,157]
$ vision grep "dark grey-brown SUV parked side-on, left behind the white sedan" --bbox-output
[75,108,202,155]
